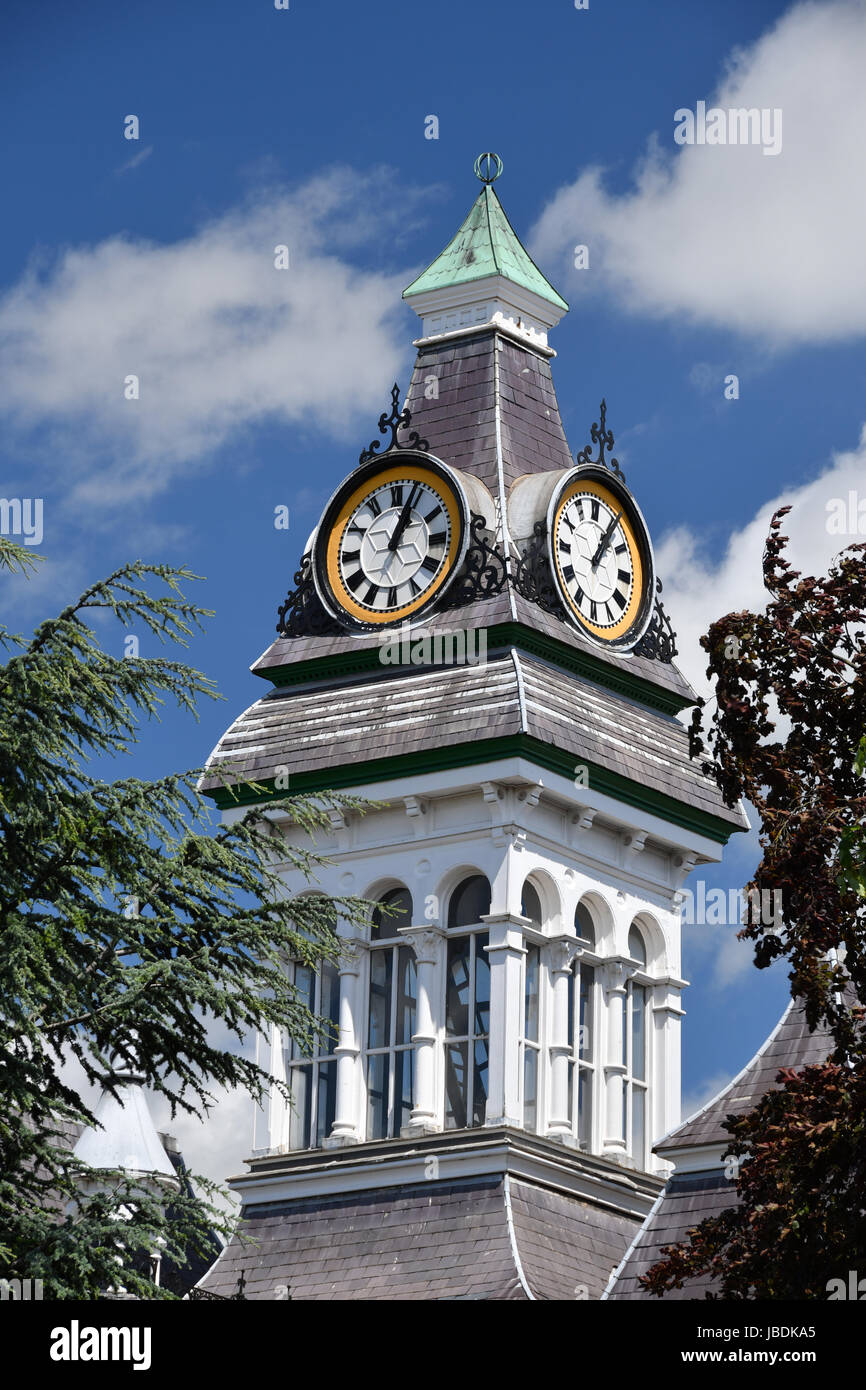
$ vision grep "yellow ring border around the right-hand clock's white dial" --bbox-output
[548,468,655,649]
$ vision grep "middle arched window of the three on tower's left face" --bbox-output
[366,887,417,1138]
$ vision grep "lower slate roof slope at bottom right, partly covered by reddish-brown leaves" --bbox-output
[603,1168,737,1301]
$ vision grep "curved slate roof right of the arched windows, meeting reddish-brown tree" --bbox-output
[655,999,833,1158]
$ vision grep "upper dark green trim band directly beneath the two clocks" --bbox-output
[254,623,694,714]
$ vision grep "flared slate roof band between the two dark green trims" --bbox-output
[203,651,742,828]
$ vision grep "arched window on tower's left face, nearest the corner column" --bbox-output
[445,874,491,1129]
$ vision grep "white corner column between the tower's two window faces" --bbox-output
[481,912,531,1127]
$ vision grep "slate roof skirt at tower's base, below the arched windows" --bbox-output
[202,1175,637,1301]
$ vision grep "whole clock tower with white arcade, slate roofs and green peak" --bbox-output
[198,154,746,1300]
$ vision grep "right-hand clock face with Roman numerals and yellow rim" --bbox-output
[549,470,652,646]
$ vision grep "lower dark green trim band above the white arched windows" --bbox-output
[207,734,745,845]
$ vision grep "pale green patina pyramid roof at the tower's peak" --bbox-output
[403,183,569,310]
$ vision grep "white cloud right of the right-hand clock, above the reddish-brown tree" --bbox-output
[656,425,866,695]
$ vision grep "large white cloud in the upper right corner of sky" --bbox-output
[532,0,866,346]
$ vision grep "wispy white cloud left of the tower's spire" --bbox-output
[0,170,421,507]
